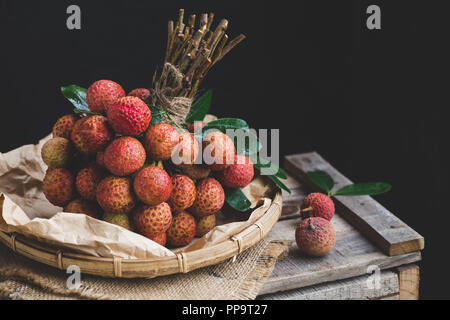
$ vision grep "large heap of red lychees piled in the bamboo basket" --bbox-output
[41,80,254,247]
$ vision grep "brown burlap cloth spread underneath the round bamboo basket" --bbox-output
[0,239,288,300]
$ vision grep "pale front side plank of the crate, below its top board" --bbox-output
[257,271,399,300]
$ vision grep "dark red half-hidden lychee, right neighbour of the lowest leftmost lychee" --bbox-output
[75,165,108,201]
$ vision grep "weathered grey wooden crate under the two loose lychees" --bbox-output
[258,153,424,300]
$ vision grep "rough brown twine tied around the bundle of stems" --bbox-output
[149,62,192,125]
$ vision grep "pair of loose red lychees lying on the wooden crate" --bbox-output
[295,192,336,257]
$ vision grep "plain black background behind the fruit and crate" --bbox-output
[0,0,449,298]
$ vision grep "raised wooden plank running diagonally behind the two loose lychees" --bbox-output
[284,152,424,256]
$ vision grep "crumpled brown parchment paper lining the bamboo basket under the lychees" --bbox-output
[0,136,271,259]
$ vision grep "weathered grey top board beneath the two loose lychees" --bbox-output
[259,164,421,295]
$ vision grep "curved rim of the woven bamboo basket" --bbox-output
[0,192,282,278]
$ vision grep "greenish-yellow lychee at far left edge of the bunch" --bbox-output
[41,137,74,168]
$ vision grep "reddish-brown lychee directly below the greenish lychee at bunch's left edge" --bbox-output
[42,168,75,207]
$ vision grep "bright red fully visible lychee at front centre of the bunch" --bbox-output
[133,166,172,206]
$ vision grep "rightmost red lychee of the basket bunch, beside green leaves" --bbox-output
[218,155,255,188]
